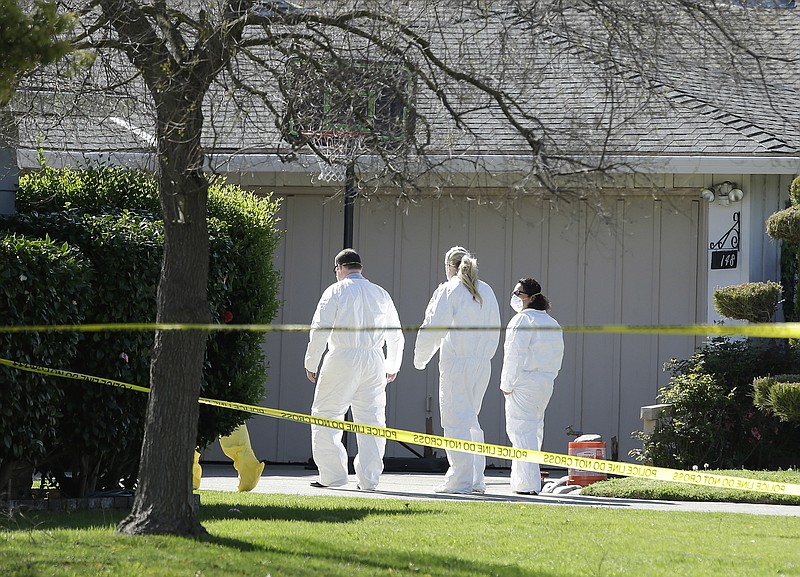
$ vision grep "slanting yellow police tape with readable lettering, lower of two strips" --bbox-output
[0,359,800,495]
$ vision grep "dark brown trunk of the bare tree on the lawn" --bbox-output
[117,94,210,535]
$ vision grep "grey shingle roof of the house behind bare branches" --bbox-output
[6,3,800,170]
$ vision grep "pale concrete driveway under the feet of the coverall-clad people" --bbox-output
[200,464,800,517]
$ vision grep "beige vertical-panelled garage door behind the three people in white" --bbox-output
[238,189,706,465]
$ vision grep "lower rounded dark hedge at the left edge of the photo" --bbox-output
[0,234,93,492]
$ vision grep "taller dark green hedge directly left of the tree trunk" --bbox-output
[4,209,163,495]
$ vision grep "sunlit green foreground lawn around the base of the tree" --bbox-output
[0,491,800,577]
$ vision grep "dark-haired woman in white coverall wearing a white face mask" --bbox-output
[500,278,564,495]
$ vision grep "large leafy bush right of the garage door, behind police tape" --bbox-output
[632,338,800,469]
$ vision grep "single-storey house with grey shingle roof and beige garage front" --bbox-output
[1,4,800,465]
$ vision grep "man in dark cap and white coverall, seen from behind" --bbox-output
[305,249,405,491]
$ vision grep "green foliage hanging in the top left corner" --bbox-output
[0,0,75,106]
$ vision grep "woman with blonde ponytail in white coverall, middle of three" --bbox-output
[414,246,500,494]
